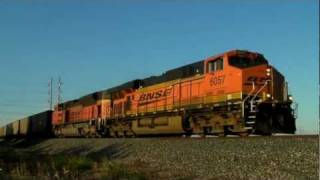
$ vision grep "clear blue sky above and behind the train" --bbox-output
[0,0,319,133]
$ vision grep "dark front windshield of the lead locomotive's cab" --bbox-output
[229,55,267,68]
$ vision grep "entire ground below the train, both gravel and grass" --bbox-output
[0,136,319,180]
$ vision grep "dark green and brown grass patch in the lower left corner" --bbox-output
[0,148,146,180]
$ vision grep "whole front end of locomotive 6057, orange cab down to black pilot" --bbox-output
[205,50,296,134]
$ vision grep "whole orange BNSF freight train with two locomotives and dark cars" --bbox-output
[0,50,296,137]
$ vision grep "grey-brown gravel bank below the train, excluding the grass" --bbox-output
[0,136,319,180]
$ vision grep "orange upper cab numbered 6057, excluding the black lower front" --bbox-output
[205,51,270,101]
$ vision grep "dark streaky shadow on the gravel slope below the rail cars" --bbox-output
[0,138,133,162]
